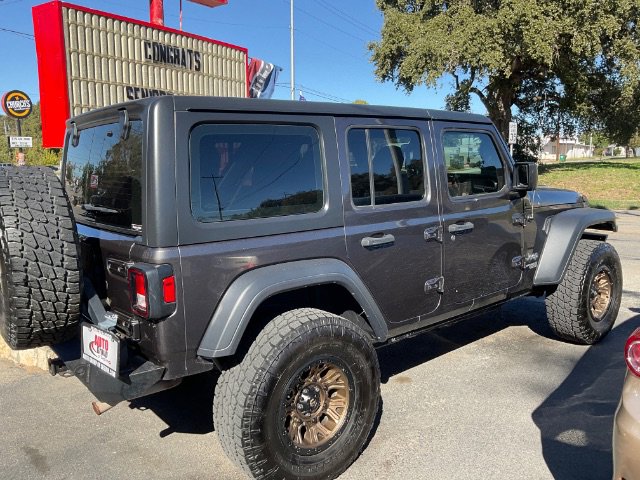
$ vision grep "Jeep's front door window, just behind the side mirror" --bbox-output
[443,132,505,197]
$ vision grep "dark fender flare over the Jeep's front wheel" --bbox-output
[533,208,618,286]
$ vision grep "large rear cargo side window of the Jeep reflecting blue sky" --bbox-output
[190,124,324,222]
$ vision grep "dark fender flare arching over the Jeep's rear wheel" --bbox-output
[198,258,388,358]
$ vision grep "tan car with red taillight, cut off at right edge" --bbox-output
[613,328,640,480]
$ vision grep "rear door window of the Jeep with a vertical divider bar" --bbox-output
[347,128,425,206]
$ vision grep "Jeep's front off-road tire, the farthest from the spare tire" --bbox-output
[545,240,622,345]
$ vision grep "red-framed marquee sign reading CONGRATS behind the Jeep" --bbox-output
[33,0,248,148]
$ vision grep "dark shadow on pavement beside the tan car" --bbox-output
[532,315,640,480]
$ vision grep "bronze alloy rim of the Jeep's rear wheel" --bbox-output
[284,361,350,449]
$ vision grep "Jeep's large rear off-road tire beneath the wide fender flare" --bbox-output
[213,309,380,480]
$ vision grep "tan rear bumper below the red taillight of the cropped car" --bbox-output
[613,373,640,480]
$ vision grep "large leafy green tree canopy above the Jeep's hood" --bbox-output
[369,0,640,143]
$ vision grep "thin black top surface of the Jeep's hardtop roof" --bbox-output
[67,95,491,124]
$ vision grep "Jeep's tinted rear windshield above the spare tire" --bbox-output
[64,120,142,232]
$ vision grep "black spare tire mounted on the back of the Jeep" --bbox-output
[0,167,80,349]
